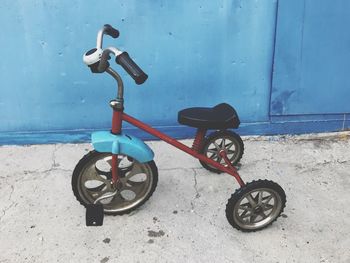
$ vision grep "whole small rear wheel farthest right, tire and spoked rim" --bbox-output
[226,180,286,232]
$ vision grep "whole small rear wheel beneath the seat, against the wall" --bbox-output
[200,130,244,173]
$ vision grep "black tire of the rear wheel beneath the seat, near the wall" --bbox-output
[199,130,244,174]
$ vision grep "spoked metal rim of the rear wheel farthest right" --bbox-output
[233,188,282,229]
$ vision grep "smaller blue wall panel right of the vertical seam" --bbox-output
[271,0,350,115]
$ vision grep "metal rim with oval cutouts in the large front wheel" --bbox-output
[78,153,153,212]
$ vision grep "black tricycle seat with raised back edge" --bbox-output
[178,103,240,129]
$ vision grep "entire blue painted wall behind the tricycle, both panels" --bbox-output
[0,0,350,144]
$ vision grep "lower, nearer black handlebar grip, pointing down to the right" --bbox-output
[115,52,148,85]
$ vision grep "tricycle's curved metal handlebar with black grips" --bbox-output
[93,24,148,85]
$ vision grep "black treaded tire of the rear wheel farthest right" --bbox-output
[225,180,286,232]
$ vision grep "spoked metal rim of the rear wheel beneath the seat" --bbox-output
[204,136,239,166]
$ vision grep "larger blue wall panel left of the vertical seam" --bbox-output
[0,0,276,140]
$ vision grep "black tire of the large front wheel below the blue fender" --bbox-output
[72,151,158,215]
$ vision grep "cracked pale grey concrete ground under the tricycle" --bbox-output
[0,132,350,263]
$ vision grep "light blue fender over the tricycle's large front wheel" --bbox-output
[91,131,154,163]
